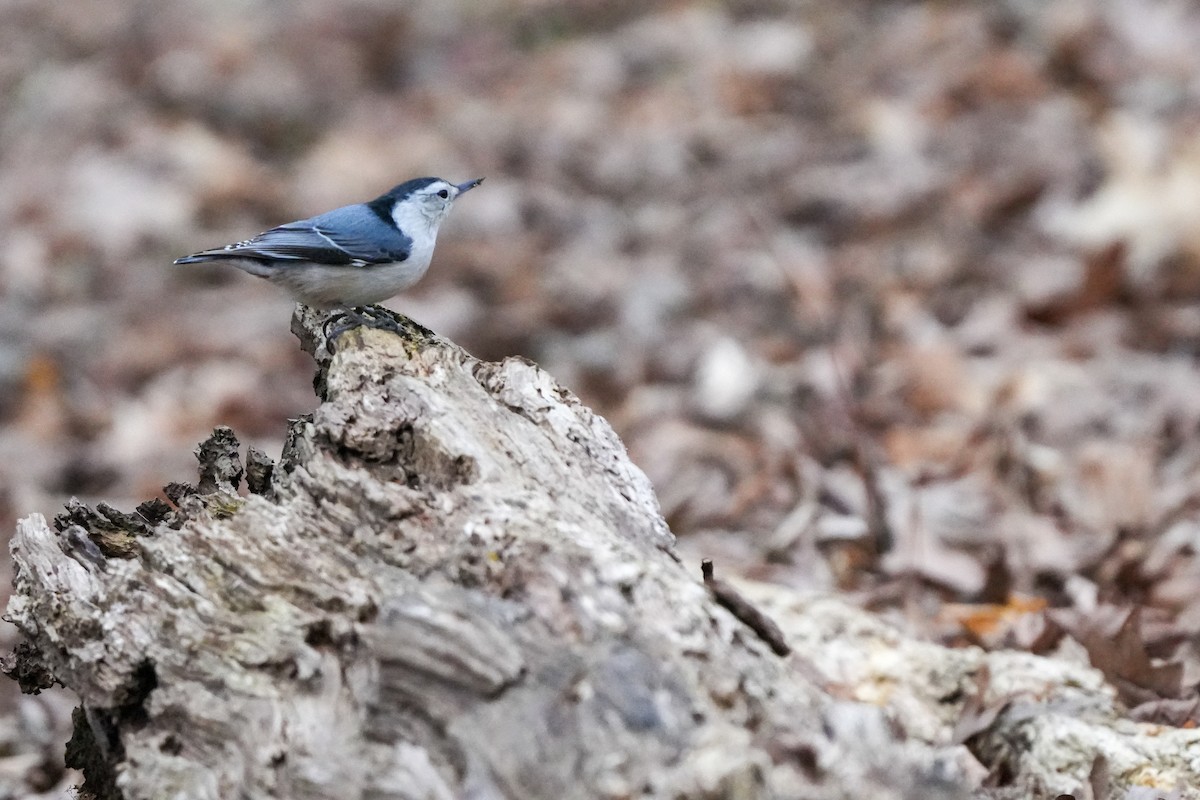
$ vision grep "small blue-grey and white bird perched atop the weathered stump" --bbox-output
[175,178,484,339]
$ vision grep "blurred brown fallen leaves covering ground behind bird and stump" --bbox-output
[0,0,1200,796]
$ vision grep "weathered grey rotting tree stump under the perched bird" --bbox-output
[8,311,966,800]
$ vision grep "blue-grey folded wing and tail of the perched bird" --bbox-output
[176,206,413,266]
